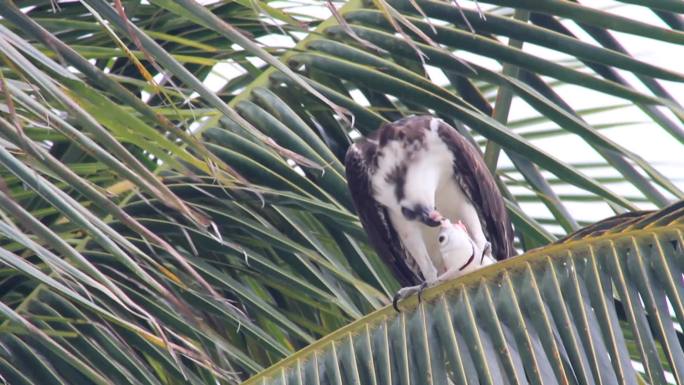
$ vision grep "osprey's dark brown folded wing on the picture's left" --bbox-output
[345,142,421,286]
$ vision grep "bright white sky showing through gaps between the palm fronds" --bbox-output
[199,0,684,236]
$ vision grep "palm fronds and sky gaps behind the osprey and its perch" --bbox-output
[0,0,684,384]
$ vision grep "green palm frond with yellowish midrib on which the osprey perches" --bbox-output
[245,204,684,384]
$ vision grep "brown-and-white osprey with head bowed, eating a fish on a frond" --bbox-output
[345,116,515,308]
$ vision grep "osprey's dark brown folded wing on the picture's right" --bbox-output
[438,122,516,260]
